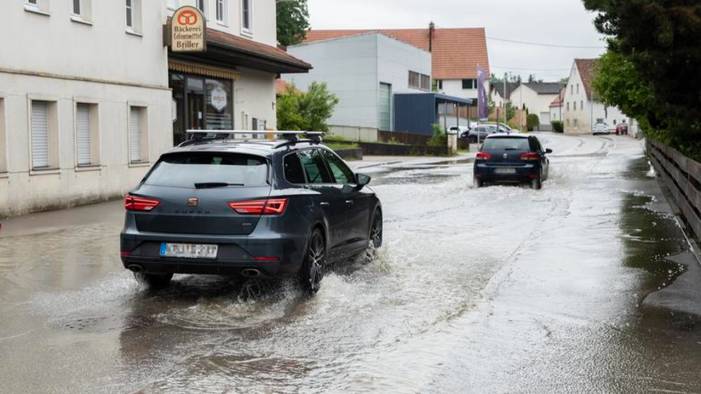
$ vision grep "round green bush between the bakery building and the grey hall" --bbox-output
[277,82,338,131]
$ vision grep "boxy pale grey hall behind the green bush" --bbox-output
[283,32,431,140]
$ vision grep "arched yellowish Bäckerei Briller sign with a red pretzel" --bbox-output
[166,6,207,52]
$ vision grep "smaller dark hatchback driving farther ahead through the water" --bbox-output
[474,134,552,189]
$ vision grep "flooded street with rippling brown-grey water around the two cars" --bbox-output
[0,134,701,393]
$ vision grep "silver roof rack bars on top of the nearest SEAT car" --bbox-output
[178,129,324,148]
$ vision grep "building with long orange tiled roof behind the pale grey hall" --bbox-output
[305,24,490,99]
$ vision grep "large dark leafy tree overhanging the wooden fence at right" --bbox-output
[584,0,701,155]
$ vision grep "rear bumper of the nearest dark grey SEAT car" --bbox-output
[121,231,307,278]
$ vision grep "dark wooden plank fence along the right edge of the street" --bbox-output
[647,140,701,239]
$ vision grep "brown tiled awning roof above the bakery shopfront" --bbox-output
[169,29,312,74]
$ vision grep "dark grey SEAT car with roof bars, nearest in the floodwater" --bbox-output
[121,135,382,293]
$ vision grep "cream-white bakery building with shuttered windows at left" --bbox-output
[0,0,309,217]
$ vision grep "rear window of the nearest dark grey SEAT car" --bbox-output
[145,152,268,188]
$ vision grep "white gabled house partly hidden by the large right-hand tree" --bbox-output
[563,59,635,134]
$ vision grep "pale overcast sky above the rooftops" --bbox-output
[309,0,605,81]
